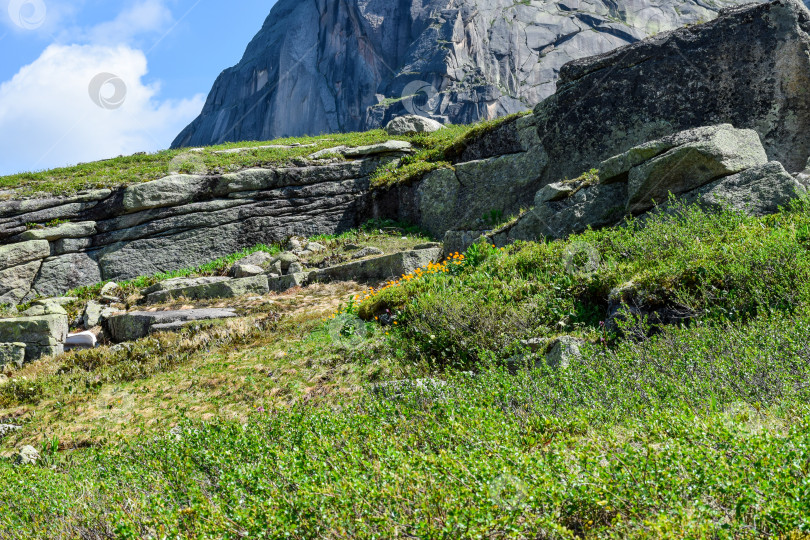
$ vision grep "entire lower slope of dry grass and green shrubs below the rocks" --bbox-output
[0,197,810,539]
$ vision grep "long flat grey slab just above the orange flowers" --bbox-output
[315,247,442,281]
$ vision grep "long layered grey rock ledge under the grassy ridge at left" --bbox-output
[0,154,400,304]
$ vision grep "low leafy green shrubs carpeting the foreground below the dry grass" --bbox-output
[0,309,810,539]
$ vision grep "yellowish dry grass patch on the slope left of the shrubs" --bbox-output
[0,282,404,451]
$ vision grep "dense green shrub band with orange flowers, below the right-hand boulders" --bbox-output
[360,201,810,365]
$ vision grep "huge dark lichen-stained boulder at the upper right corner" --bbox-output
[534,0,810,183]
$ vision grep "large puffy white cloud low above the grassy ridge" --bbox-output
[0,45,204,174]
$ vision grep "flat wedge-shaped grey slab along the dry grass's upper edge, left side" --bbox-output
[106,309,237,343]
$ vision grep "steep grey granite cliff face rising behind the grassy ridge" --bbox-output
[173,0,744,147]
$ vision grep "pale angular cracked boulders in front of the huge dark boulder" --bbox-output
[502,124,807,244]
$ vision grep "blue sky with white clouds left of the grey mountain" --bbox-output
[0,0,275,175]
